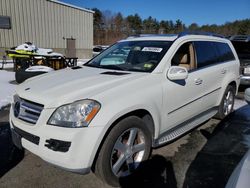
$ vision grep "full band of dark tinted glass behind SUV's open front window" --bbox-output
[194,41,235,68]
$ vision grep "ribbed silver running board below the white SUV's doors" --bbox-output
[153,107,218,147]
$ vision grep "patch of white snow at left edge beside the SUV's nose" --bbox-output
[0,70,16,109]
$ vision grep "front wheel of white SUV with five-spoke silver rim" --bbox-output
[94,116,152,186]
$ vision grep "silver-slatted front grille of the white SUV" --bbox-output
[13,98,44,124]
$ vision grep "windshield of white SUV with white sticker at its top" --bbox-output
[85,41,172,72]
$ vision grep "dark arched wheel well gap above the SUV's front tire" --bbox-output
[91,109,155,172]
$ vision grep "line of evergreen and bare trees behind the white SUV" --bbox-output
[92,8,250,44]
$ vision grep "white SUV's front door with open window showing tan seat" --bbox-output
[160,42,203,133]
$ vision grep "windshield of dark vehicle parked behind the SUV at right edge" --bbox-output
[232,41,250,59]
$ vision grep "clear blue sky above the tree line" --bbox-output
[62,0,250,25]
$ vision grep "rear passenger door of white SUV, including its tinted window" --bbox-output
[194,41,224,110]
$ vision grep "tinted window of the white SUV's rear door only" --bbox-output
[194,41,218,68]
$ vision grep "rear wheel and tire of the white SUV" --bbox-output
[215,85,235,119]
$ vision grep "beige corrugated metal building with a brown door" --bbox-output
[0,0,94,59]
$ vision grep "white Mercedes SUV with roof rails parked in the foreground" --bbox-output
[10,33,239,186]
